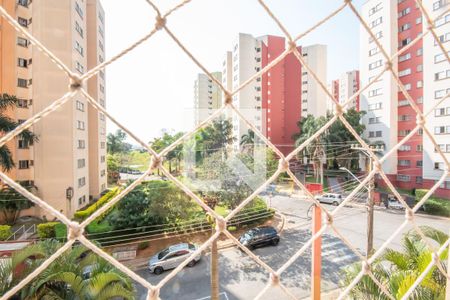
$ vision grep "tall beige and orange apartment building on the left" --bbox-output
[0,0,106,218]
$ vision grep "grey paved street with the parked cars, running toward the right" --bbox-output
[132,196,448,300]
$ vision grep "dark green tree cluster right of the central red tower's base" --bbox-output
[292,109,365,178]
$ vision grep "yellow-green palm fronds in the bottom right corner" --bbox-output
[342,226,449,300]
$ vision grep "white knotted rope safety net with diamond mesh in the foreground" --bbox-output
[0,0,450,300]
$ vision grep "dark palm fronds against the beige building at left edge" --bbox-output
[0,94,38,171]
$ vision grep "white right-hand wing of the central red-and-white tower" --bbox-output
[301,45,327,117]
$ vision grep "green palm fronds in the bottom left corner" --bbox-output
[0,240,134,300]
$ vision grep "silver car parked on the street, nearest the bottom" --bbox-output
[148,243,201,275]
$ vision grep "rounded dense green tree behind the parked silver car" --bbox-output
[108,180,195,229]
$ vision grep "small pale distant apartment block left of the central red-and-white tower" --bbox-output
[194,72,222,125]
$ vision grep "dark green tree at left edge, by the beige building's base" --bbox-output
[0,185,36,225]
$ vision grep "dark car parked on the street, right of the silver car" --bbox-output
[239,226,280,249]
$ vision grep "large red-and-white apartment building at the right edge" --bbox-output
[360,0,450,197]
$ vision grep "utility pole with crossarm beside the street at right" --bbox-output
[351,145,383,258]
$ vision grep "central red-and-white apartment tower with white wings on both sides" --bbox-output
[222,33,326,153]
